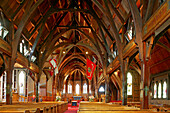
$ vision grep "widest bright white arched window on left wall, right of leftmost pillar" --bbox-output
[19,71,25,95]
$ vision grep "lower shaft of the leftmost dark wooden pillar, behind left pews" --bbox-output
[6,59,12,105]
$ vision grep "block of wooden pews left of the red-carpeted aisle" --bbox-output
[0,102,68,113]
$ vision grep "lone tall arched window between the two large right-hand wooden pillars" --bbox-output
[127,72,132,95]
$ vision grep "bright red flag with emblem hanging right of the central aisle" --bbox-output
[86,59,96,80]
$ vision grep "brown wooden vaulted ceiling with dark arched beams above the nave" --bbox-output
[1,0,140,79]
